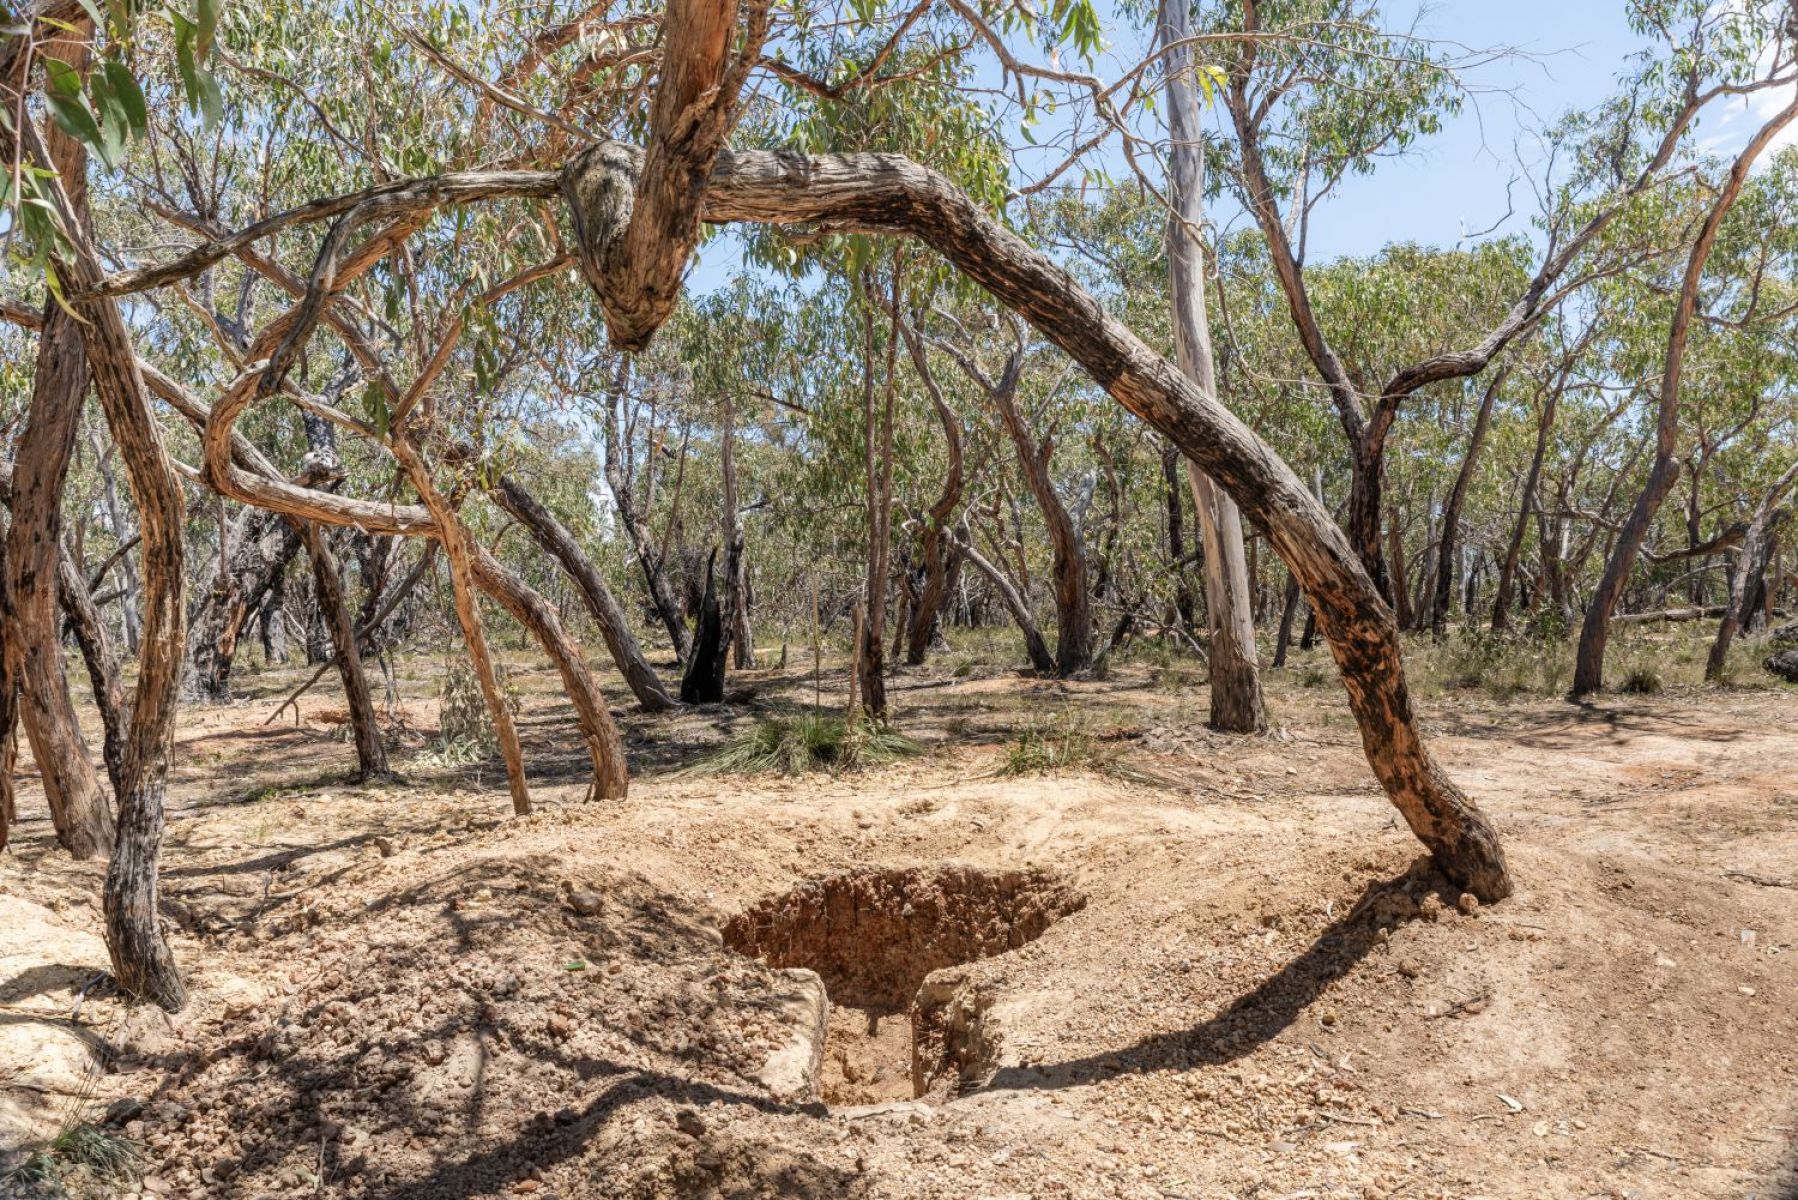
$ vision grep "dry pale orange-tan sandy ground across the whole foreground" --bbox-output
[0,647,1798,1200]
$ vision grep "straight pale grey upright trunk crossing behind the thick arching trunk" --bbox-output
[1162,0,1268,734]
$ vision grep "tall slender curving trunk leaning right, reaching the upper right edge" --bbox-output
[1573,99,1798,696]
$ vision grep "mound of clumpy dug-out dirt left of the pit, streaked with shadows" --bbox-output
[103,826,870,1198]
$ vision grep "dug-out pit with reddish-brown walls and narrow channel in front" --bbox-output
[725,865,1086,1105]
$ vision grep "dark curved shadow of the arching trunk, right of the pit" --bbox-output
[985,860,1402,1090]
